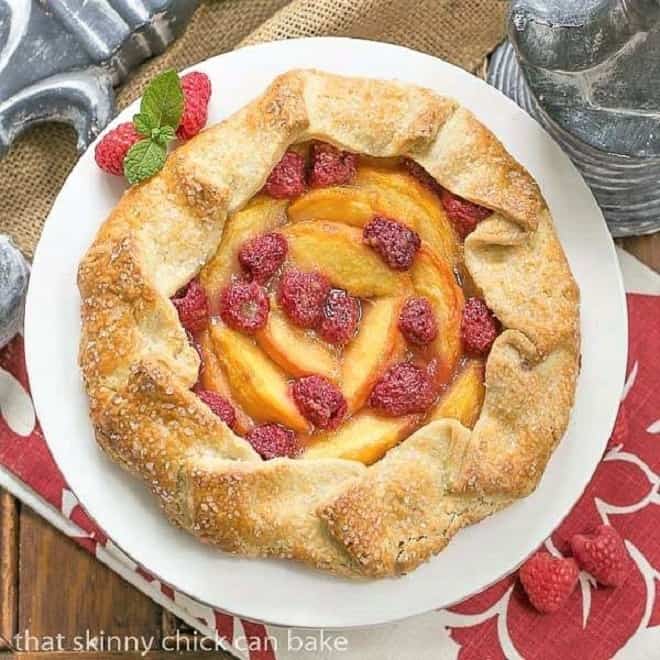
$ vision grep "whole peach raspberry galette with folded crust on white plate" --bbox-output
[79,71,579,577]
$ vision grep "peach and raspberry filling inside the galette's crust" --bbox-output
[174,146,499,464]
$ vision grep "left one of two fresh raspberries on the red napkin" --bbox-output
[519,552,580,614]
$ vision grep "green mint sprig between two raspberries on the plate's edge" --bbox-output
[124,70,184,184]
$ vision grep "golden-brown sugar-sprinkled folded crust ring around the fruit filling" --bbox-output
[78,71,579,577]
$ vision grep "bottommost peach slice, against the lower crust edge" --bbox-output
[301,410,418,465]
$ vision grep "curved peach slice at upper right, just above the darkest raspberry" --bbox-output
[355,167,458,265]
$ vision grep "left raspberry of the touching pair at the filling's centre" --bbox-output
[278,268,330,328]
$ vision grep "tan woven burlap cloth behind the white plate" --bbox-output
[0,0,506,256]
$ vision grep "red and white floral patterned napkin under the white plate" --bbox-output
[0,251,660,660]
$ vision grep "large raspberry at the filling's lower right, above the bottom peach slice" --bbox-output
[369,362,435,417]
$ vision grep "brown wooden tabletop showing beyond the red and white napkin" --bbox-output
[0,234,660,660]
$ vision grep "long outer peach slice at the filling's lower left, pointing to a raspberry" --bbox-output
[211,323,309,433]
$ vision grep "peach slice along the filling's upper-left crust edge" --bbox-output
[199,195,287,314]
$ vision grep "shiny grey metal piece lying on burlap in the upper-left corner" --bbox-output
[0,0,198,156]
